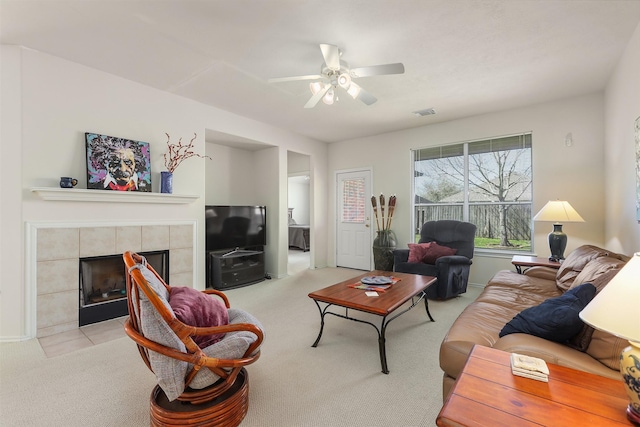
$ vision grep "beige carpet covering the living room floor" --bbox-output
[0,268,480,427]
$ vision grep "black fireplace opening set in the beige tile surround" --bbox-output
[79,250,169,326]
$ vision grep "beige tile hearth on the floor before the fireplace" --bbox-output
[38,316,127,357]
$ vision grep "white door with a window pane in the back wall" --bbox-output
[336,169,371,271]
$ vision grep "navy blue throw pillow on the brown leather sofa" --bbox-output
[499,283,596,343]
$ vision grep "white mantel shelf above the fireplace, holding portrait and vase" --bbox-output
[31,187,200,204]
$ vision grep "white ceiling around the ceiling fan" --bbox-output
[0,0,640,144]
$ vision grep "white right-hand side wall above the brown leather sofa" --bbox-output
[604,24,640,255]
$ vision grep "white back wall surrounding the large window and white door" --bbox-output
[328,93,605,284]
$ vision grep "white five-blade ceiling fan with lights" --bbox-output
[268,44,404,108]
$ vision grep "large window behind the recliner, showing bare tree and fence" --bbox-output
[413,134,533,251]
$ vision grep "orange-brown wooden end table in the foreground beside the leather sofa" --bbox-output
[436,345,631,427]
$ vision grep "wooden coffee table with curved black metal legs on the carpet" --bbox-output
[309,270,437,374]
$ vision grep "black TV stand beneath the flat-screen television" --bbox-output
[207,246,266,290]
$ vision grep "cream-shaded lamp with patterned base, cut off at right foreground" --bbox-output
[580,252,640,426]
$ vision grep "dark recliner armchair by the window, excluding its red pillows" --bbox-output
[393,220,476,299]
